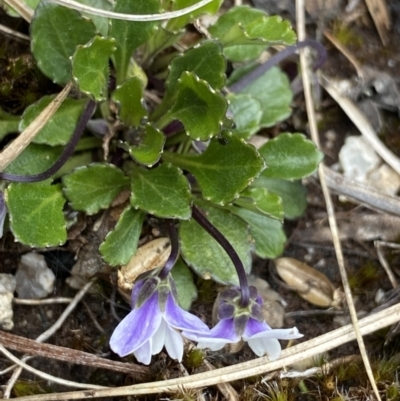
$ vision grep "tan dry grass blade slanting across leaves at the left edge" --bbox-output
[0,82,73,171]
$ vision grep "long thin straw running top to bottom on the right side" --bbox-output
[296,0,381,401]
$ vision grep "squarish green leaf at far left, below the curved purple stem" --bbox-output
[5,180,67,248]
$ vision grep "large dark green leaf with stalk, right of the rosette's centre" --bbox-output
[163,132,264,205]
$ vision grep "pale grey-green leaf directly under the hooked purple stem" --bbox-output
[239,67,293,128]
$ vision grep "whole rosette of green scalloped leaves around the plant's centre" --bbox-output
[1,0,321,300]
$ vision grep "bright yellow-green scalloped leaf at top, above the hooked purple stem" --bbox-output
[209,6,296,62]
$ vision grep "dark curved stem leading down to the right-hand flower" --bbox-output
[192,205,250,307]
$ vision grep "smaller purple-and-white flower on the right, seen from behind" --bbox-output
[182,287,303,360]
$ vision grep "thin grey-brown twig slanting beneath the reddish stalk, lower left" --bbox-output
[3,279,95,399]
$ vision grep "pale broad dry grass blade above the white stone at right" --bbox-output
[319,74,400,174]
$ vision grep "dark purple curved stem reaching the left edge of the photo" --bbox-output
[0,100,96,182]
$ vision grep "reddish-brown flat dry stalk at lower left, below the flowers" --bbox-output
[0,331,150,376]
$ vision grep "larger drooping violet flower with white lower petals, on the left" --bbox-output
[110,275,210,365]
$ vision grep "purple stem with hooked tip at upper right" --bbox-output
[228,39,327,92]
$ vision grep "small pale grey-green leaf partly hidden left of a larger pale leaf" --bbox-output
[227,95,262,139]
